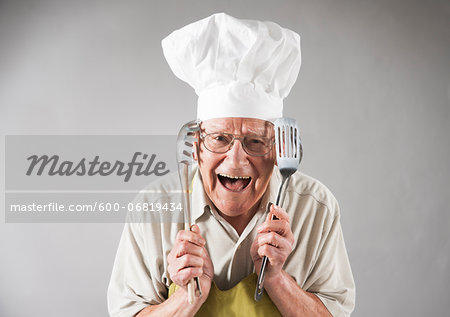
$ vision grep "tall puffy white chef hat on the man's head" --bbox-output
[162,13,301,120]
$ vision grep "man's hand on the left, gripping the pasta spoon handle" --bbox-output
[167,225,214,301]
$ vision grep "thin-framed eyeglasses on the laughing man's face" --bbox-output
[200,132,275,156]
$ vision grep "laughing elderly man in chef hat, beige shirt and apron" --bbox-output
[108,14,355,316]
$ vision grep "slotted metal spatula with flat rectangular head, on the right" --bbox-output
[255,118,303,301]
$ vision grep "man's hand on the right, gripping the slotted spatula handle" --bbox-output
[250,205,294,280]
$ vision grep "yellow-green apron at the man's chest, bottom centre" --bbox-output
[169,273,281,317]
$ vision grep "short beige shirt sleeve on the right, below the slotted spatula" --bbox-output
[304,207,355,317]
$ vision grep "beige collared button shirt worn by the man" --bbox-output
[108,168,355,316]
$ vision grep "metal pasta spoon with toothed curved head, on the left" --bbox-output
[177,120,202,304]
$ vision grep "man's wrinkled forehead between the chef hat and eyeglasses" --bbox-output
[201,118,274,136]
